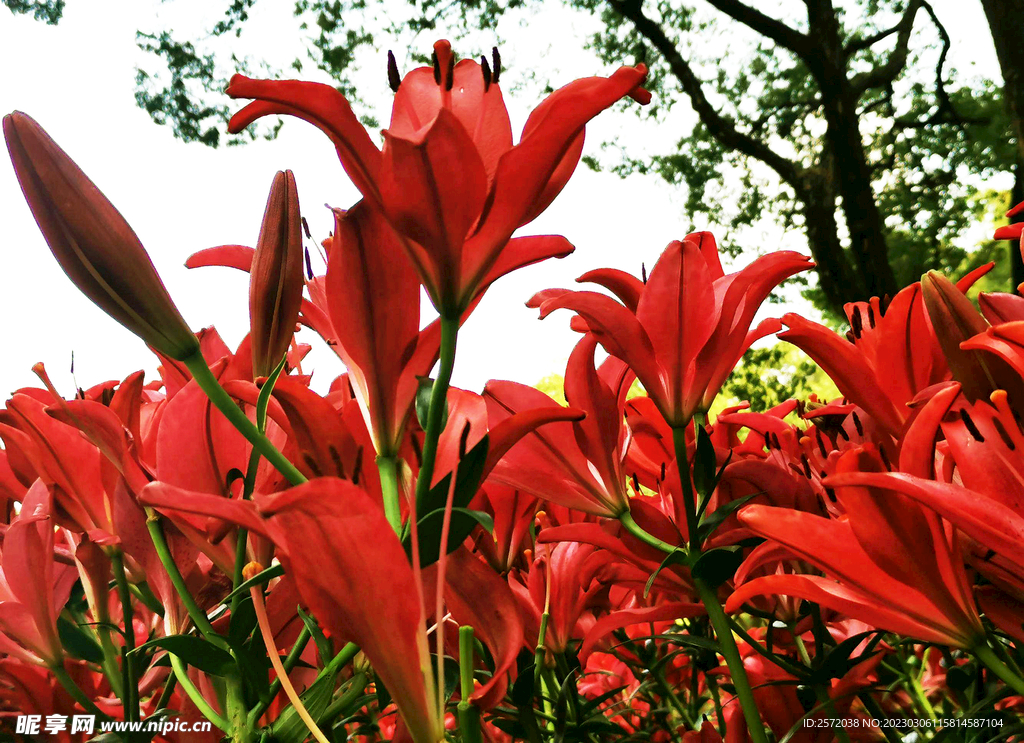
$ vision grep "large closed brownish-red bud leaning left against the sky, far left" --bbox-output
[3,112,199,360]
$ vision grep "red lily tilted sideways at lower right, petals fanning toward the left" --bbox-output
[726,445,984,648]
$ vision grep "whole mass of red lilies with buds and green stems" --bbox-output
[0,37,1024,743]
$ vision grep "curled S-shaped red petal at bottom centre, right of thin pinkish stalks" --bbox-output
[444,548,523,710]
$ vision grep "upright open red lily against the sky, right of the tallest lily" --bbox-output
[541,232,813,427]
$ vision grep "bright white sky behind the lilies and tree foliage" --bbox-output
[0,0,1009,396]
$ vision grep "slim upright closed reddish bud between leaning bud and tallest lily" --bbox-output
[249,170,303,377]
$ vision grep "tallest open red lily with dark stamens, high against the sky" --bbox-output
[227,41,649,317]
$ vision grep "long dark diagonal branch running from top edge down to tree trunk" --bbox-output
[610,0,802,189]
